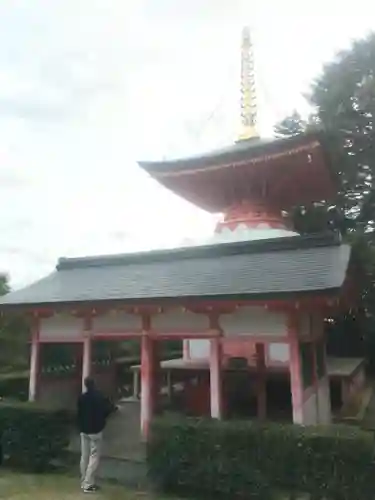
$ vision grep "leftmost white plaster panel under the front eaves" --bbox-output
[39,314,84,342]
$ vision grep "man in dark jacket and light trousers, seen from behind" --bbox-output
[78,378,112,493]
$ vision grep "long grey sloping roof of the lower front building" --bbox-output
[0,237,350,308]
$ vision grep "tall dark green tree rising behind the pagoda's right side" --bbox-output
[275,34,375,359]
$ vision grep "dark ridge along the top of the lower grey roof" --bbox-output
[56,232,342,271]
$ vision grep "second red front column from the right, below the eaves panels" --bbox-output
[210,338,223,420]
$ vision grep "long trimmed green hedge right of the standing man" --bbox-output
[147,419,375,500]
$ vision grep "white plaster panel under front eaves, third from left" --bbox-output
[151,309,210,333]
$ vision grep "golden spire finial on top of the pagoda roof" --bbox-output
[239,27,259,140]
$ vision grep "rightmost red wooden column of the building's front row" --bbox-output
[288,313,303,424]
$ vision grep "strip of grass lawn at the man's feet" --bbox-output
[0,469,168,500]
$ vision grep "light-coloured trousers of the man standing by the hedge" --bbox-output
[81,432,103,488]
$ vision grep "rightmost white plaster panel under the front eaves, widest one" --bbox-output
[219,307,287,337]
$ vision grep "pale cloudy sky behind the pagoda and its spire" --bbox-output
[0,0,375,288]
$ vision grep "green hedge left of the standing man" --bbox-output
[0,402,72,472]
